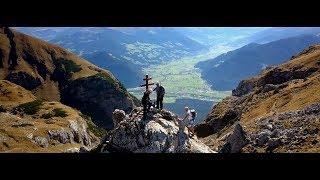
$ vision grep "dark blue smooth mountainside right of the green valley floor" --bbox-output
[196,35,320,90]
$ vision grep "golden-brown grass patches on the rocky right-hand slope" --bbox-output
[202,45,320,152]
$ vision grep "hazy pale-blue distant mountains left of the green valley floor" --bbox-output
[16,27,207,87]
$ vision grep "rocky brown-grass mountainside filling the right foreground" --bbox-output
[195,45,320,152]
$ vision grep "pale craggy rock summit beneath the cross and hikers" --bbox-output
[102,110,218,153]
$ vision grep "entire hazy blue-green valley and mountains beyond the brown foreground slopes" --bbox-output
[16,27,320,122]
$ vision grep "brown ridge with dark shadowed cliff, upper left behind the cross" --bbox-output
[0,28,138,128]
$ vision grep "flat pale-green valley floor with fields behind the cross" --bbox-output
[128,45,232,122]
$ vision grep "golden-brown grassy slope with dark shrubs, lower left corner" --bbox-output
[0,80,102,152]
